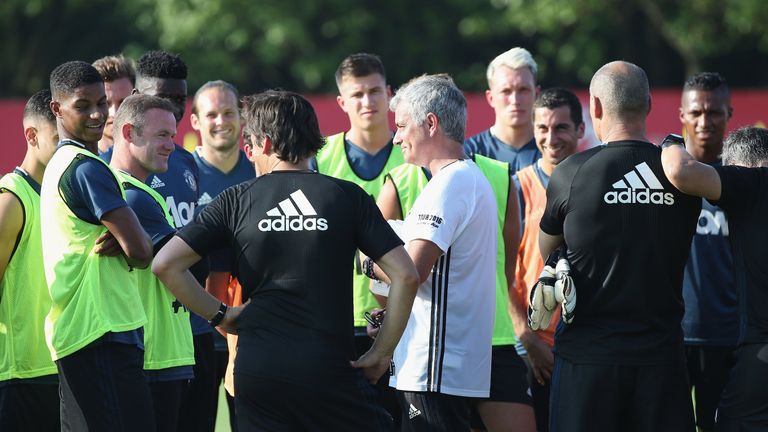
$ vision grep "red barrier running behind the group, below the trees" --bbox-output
[0,89,768,173]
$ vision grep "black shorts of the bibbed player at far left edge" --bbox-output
[0,375,61,432]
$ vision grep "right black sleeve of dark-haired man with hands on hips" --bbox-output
[353,186,403,261]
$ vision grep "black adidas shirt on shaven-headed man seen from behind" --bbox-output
[540,141,701,365]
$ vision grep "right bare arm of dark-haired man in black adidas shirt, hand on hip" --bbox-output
[351,245,416,382]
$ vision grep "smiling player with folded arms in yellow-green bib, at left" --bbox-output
[40,61,154,430]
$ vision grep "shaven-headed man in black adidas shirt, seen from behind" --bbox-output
[539,61,701,432]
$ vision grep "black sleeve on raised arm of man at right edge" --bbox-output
[710,165,768,212]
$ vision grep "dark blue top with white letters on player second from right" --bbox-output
[683,163,739,346]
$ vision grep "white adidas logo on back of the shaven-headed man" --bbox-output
[603,162,675,205]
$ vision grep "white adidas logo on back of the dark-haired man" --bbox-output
[258,189,328,231]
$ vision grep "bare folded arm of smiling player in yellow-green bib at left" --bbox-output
[101,207,152,268]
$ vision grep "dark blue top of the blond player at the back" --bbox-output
[464,129,541,174]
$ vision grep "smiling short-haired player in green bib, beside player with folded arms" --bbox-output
[111,95,195,431]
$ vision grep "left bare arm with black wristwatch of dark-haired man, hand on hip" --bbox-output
[152,236,242,333]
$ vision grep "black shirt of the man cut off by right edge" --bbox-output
[713,166,768,343]
